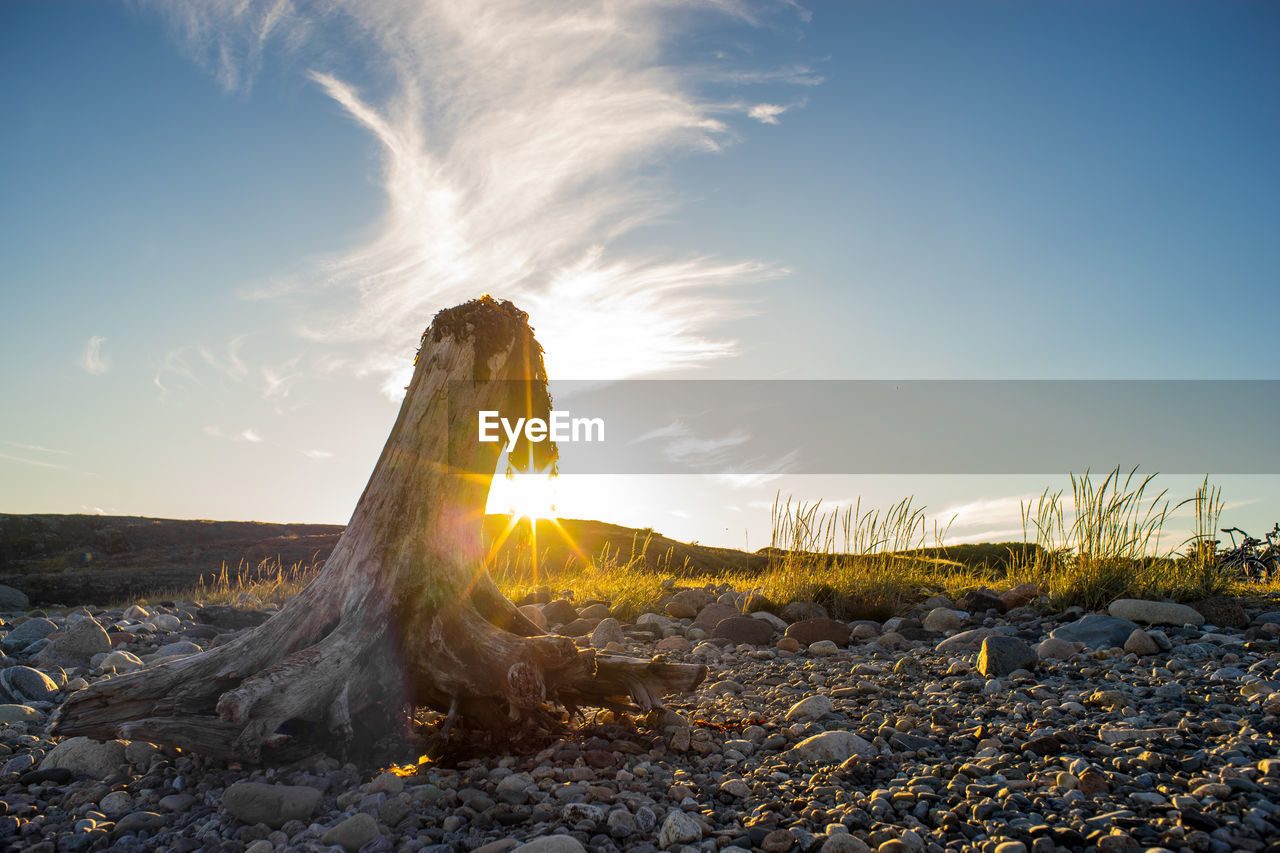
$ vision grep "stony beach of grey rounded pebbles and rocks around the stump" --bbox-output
[0,585,1280,853]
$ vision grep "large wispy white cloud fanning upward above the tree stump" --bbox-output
[137,0,818,397]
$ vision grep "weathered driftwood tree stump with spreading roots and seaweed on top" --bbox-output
[52,297,707,761]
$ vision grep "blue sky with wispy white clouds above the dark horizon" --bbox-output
[0,0,1280,549]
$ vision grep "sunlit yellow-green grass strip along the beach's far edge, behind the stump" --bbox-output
[145,467,1280,620]
